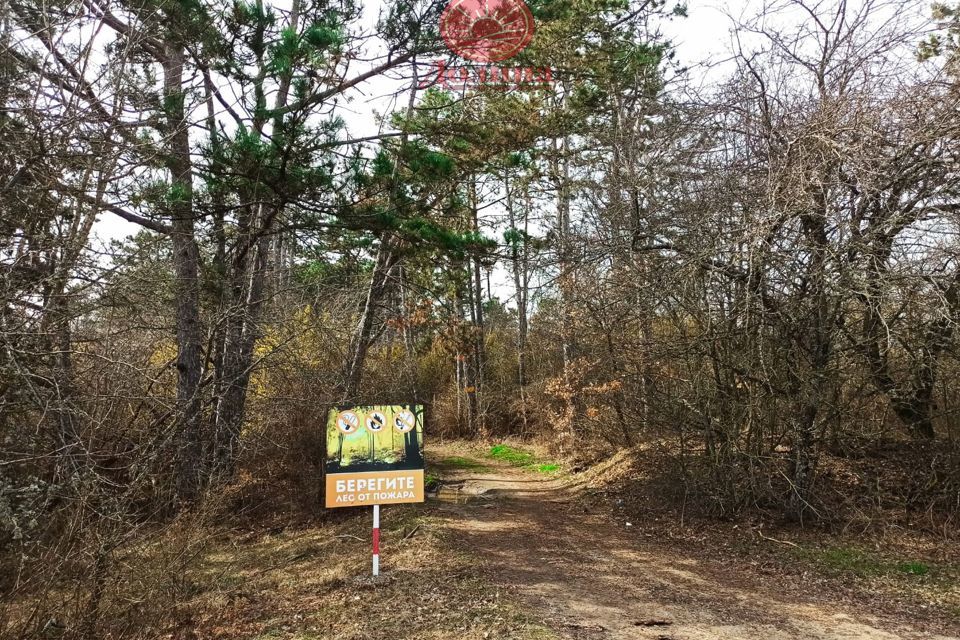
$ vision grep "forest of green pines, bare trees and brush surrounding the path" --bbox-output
[0,0,960,638]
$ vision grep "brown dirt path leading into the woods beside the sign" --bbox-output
[432,448,951,640]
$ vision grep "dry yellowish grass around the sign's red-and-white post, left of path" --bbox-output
[168,505,552,640]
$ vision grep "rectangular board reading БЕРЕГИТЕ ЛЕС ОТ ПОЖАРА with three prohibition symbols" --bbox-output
[325,404,424,509]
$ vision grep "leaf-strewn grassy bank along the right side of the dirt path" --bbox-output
[576,445,960,628]
